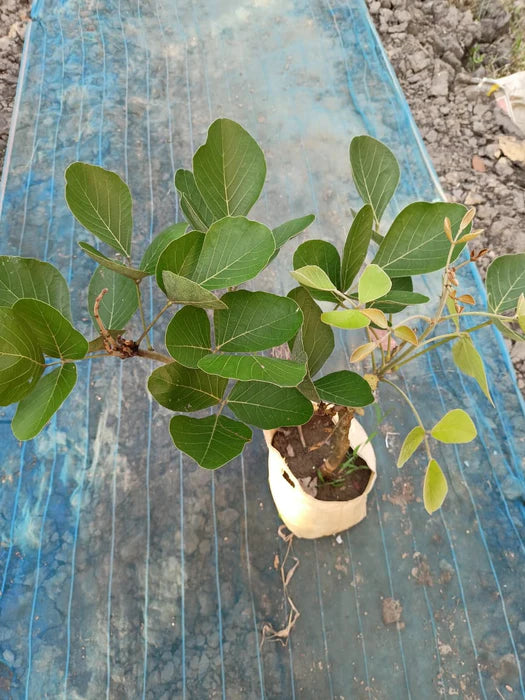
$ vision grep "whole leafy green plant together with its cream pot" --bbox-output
[0,119,525,537]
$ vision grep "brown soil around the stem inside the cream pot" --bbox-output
[272,413,372,501]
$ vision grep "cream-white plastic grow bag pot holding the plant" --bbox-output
[264,418,377,539]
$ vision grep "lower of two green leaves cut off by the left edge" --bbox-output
[0,307,44,406]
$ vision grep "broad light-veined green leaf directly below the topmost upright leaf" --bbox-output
[193,216,275,289]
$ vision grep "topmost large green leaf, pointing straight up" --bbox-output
[193,119,266,219]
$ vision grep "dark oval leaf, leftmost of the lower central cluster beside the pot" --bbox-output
[148,362,228,412]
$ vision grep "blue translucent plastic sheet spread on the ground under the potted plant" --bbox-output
[0,0,525,700]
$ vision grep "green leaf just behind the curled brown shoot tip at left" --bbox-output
[88,267,138,328]
